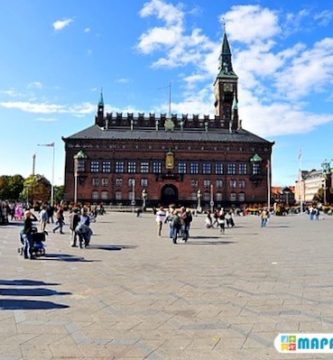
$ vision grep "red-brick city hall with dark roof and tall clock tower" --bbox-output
[63,34,274,207]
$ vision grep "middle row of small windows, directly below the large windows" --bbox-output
[91,177,246,189]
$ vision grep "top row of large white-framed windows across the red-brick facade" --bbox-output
[87,160,260,175]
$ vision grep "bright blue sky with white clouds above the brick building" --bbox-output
[0,0,333,186]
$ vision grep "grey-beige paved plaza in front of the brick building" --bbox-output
[0,212,333,360]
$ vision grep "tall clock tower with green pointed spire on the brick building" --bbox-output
[214,33,239,131]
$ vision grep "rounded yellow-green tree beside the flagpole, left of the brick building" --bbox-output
[21,175,51,204]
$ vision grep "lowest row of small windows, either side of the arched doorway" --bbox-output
[91,191,245,203]
